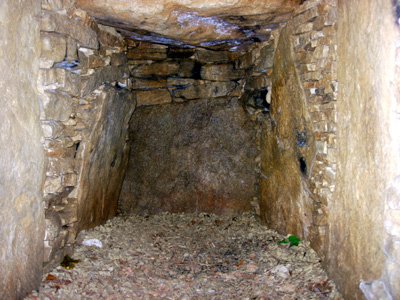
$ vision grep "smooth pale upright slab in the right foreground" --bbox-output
[328,0,400,299]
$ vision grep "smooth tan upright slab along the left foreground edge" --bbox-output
[0,0,44,300]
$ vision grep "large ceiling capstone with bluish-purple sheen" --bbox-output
[77,0,302,51]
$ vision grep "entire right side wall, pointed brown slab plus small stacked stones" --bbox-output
[260,1,337,257]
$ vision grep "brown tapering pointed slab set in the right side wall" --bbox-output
[260,28,315,237]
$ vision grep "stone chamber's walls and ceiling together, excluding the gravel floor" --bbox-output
[0,0,400,299]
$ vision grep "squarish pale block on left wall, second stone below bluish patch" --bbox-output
[39,90,73,121]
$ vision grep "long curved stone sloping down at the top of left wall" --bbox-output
[40,10,98,49]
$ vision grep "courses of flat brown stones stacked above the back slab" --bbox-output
[127,41,245,106]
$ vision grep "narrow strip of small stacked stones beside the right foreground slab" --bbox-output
[288,1,337,257]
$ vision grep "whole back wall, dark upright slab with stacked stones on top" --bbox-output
[120,41,264,213]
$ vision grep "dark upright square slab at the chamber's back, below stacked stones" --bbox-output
[120,98,256,213]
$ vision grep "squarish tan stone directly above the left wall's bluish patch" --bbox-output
[40,32,67,62]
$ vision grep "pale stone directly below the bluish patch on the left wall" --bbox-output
[38,68,81,96]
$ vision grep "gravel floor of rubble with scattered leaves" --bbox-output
[26,213,342,300]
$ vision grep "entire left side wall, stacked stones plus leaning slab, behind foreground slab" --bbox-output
[37,1,135,270]
